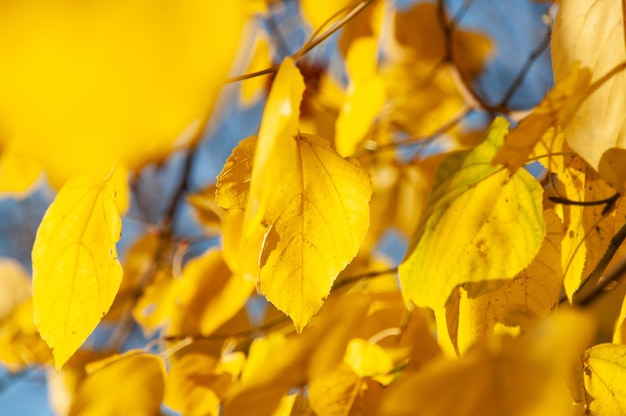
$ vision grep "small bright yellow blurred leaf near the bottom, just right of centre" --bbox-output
[343,338,393,385]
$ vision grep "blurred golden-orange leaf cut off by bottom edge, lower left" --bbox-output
[69,351,165,416]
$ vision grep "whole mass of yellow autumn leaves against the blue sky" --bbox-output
[0,0,626,415]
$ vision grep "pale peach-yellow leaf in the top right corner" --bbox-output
[552,0,626,189]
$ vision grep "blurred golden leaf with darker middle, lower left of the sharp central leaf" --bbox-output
[168,249,256,335]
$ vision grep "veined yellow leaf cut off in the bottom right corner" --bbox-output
[584,344,626,415]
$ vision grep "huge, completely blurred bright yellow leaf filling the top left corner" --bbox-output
[0,0,246,191]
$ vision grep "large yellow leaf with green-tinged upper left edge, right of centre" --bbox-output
[399,119,545,310]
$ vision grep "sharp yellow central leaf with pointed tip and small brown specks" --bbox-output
[259,135,371,331]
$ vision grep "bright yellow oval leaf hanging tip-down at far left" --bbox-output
[32,175,122,369]
